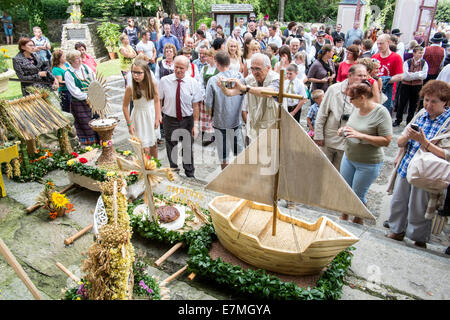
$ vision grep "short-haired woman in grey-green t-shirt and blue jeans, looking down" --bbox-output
[337,80,392,224]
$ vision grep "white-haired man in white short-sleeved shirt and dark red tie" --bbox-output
[159,56,202,178]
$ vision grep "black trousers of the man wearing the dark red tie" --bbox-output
[163,114,195,176]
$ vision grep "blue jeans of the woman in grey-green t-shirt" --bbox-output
[341,153,383,204]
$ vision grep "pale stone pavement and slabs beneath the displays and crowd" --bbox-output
[0,77,450,300]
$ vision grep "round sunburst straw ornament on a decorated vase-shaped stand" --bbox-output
[87,75,119,165]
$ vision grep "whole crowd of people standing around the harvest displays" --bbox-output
[8,10,450,252]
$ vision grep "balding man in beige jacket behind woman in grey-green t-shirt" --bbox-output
[314,64,367,171]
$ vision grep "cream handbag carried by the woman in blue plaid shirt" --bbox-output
[406,119,450,193]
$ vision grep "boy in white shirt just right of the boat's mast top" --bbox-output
[284,64,306,123]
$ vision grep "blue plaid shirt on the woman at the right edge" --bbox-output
[397,109,450,178]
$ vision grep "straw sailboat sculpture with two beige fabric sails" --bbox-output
[206,108,375,275]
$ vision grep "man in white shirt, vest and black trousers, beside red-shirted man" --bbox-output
[392,46,428,127]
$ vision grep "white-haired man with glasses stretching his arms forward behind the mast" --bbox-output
[217,53,280,139]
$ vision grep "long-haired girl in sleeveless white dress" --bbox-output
[122,60,161,158]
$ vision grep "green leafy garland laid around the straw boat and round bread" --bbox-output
[128,194,354,300]
